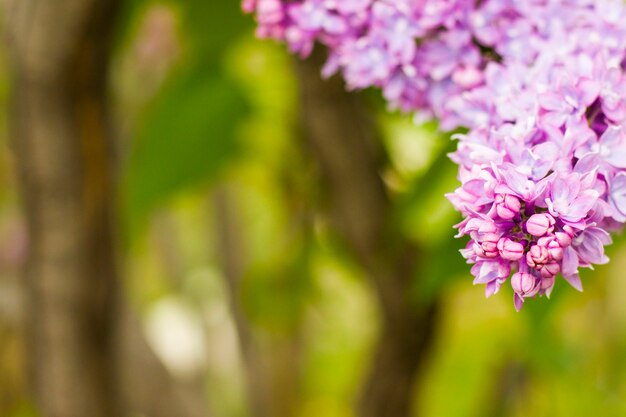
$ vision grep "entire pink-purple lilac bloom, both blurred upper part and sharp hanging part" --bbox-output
[244,0,626,309]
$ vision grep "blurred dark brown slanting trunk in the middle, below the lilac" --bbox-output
[297,51,436,417]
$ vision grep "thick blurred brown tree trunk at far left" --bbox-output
[8,0,120,417]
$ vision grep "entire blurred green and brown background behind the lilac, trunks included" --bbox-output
[0,0,626,417]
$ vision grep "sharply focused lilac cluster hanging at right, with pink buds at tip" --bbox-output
[448,0,626,309]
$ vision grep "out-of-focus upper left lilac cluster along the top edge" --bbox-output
[243,0,486,128]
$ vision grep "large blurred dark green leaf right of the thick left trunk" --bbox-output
[126,66,248,228]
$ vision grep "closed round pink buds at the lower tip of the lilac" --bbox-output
[451,190,588,309]
